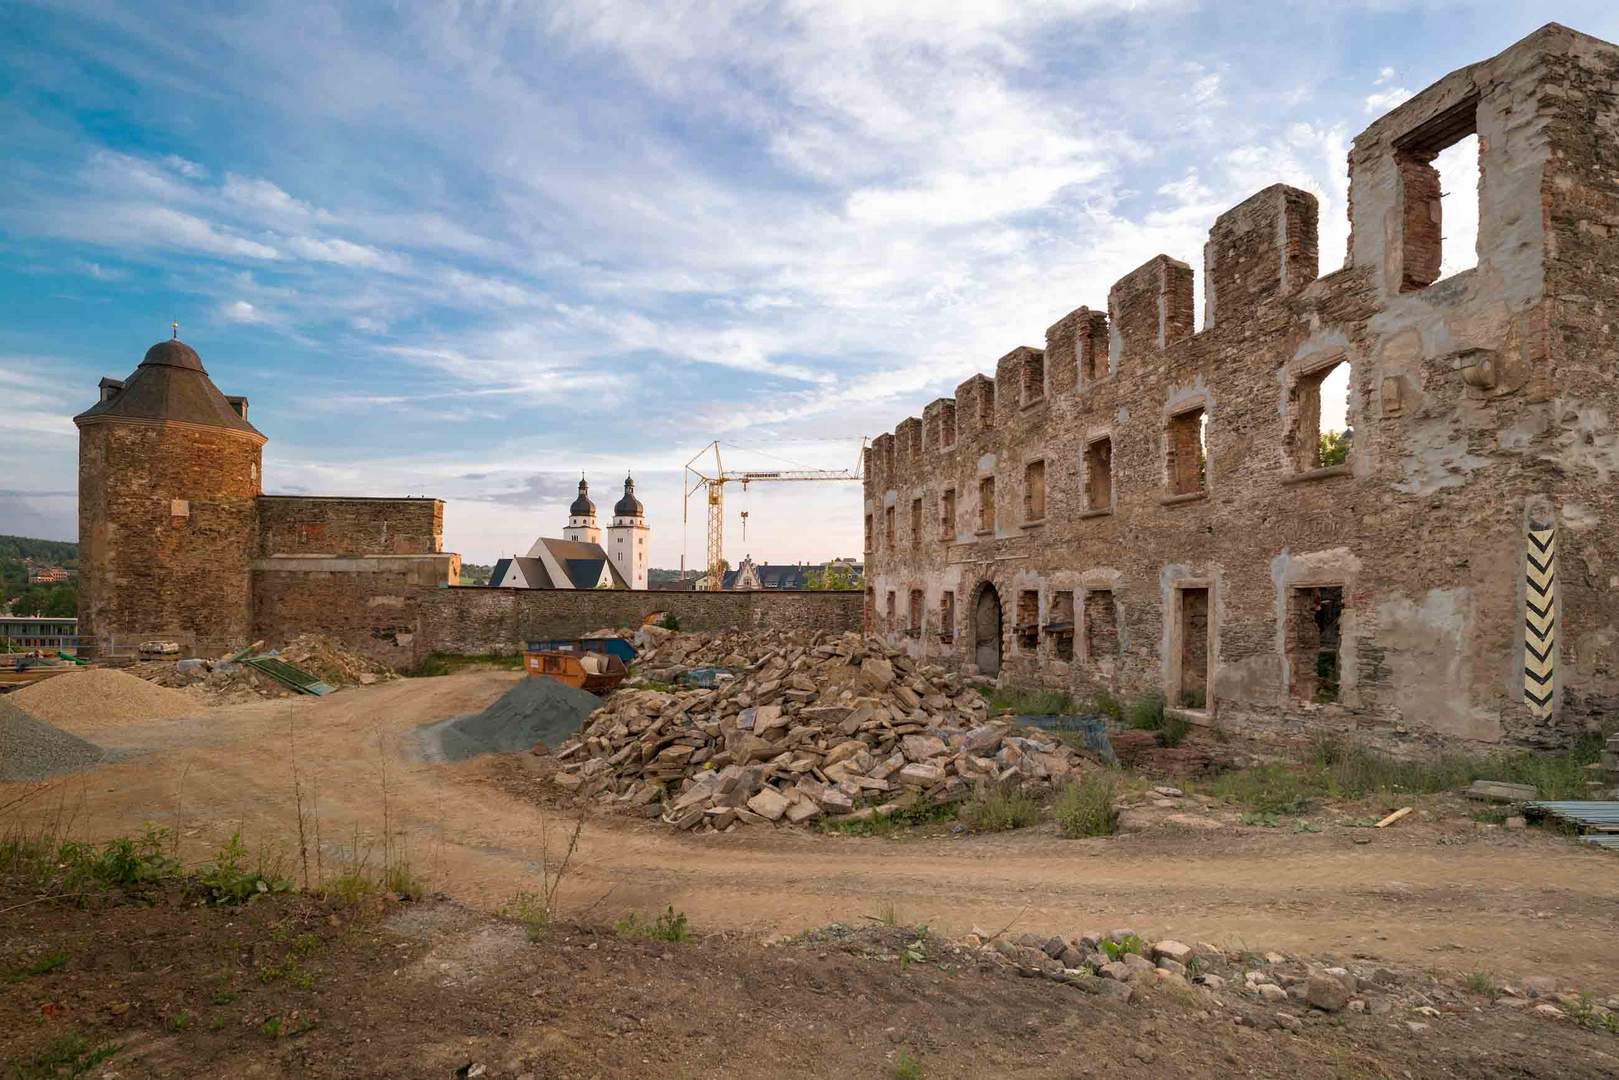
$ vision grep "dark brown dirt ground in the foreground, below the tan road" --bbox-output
[0,891,1619,1080]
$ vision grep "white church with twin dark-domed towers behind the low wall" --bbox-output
[489,476,652,589]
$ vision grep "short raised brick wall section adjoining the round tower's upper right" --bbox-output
[259,495,444,555]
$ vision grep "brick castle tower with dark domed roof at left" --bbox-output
[73,340,264,656]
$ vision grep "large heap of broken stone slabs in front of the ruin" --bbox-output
[552,631,1083,829]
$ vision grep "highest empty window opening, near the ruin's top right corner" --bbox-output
[1394,99,1483,291]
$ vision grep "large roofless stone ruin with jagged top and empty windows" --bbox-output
[865,24,1619,745]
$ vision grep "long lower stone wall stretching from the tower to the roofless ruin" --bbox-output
[254,569,860,669]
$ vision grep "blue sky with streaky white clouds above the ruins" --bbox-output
[0,0,1619,567]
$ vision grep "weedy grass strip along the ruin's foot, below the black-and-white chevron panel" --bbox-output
[1200,737,1601,814]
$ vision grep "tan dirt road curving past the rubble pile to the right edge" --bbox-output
[0,672,1619,993]
